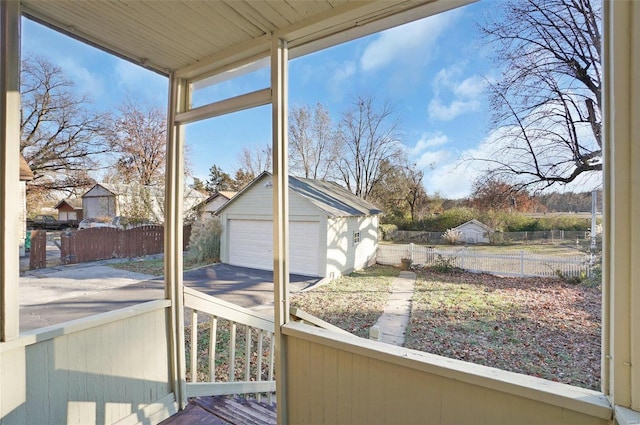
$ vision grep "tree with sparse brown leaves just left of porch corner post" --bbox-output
[109,99,167,186]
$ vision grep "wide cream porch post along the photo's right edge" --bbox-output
[602,1,640,412]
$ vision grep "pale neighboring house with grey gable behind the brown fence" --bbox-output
[82,183,206,222]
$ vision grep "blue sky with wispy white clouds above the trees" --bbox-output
[22,2,498,198]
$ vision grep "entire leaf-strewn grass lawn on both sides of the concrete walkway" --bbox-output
[117,257,602,390]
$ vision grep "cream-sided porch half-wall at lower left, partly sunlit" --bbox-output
[0,301,171,424]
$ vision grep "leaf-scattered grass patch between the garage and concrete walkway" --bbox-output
[291,265,399,338]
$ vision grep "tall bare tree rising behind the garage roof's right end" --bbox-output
[336,96,401,199]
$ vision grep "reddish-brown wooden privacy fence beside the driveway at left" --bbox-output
[60,226,191,264]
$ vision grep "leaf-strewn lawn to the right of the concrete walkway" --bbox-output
[405,270,602,390]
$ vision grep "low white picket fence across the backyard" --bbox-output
[376,244,590,277]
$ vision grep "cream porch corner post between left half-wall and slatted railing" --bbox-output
[164,74,188,409]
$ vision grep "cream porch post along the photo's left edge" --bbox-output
[0,0,20,341]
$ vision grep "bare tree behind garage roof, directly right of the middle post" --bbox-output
[289,103,340,180]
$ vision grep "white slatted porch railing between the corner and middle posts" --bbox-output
[184,288,276,403]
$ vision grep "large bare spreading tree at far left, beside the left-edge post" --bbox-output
[20,57,107,205]
